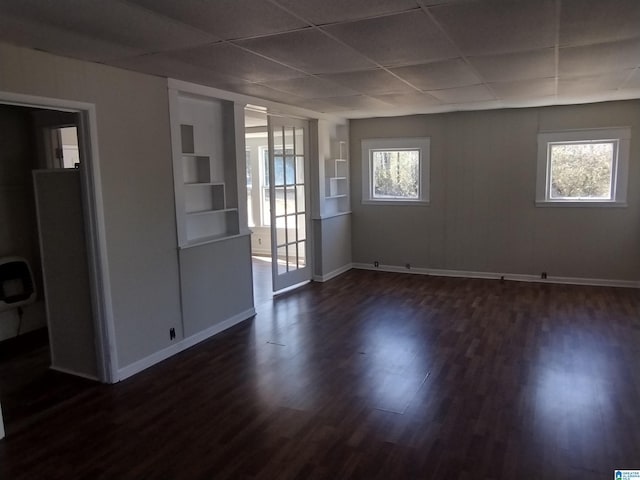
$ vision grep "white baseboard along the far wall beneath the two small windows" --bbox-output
[353,263,640,288]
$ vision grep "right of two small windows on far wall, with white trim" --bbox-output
[536,128,631,206]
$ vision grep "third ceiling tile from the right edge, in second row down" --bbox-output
[391,58,482,90]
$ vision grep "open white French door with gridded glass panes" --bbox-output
[268,116,311,292]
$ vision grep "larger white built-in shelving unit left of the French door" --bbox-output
[171,92,239,248]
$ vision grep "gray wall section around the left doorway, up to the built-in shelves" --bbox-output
[0,43,180,368]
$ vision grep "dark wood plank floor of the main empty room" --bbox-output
[0,270,640,479]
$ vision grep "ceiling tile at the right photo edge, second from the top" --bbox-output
[558,39,640,76]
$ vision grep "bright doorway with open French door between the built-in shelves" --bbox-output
[245,105,311,306]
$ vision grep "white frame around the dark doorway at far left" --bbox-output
[0,91,119,383]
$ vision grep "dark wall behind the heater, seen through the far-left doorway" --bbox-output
[0,105,47,341]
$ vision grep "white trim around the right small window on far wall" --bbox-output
[536,127,631,207]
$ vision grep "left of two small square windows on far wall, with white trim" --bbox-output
[362,137,430,205]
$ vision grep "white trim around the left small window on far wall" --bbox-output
[361,137,431,205]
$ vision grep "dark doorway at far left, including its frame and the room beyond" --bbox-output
[0,92,116,436]
